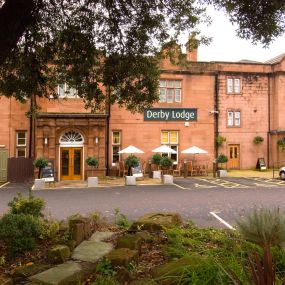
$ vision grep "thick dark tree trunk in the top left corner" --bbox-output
[0,0,35,65]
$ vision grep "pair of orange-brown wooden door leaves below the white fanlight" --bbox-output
[60,147,83,180]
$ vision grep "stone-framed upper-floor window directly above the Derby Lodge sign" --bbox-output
[159,79,181,103]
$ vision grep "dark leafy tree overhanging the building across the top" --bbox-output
[0,0,284,111]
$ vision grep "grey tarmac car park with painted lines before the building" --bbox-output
[0,177,285,231]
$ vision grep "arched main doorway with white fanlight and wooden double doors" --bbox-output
[59,130,84,180]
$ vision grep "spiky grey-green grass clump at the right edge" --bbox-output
[237,208,285,247]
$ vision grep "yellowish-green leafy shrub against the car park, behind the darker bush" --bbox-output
[8,191,45,217]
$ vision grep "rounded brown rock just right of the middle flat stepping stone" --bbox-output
[106,248,138,266]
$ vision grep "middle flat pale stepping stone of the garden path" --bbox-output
[71,241,113,262]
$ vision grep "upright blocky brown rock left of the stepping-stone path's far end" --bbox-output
[69,217,92,241]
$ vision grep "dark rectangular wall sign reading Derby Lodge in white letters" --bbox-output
[144,108,197,122]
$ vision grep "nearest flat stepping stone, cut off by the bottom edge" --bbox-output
[29,262,95,285]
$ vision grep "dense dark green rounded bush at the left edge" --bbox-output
[0,213,40,256]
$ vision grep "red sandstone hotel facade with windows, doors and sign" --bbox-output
[0,51,285,180]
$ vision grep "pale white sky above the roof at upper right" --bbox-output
[194,8,285,62]
